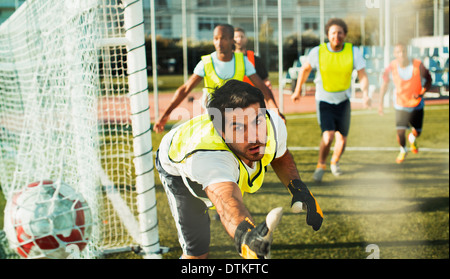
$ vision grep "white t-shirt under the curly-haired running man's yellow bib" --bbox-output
[307,43,366,104]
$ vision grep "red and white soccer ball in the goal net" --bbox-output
[4,180,92,259]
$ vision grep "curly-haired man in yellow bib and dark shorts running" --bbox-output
[291,18,370,182]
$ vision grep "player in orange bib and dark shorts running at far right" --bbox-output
[378,43,432,164]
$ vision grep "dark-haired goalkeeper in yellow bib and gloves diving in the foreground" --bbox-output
[156,80,323,259]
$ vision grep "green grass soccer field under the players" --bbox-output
[0,105,449,259]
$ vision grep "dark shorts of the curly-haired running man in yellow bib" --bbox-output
[317,100,351,137]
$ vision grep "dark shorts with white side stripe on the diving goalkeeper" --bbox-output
[155,150,210,256]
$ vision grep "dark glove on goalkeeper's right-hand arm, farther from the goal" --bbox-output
[288,179,323,231]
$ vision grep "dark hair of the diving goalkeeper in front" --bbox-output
[207,79,266,131]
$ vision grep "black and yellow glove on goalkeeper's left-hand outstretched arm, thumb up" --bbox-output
[234,207,283,259]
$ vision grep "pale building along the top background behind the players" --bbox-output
[0,0,449,45]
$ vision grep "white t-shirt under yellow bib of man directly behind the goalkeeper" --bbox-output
[194,52,256,80]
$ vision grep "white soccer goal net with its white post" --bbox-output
[0,0,160,258]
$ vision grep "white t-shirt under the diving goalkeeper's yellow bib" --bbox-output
[159,110,287,189]
